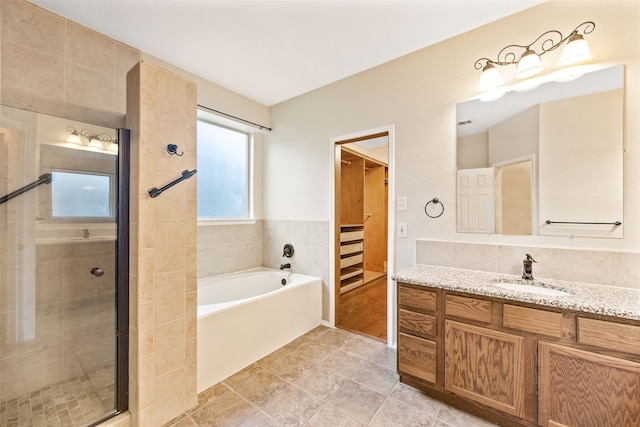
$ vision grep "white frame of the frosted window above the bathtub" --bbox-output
[196,112,256,225]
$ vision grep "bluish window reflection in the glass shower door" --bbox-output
[51,171,113,218]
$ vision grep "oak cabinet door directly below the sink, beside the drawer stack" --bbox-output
[444,320,524,417]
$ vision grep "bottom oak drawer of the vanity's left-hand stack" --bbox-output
[398,332,437,384]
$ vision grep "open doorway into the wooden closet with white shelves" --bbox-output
[333,130,394,341]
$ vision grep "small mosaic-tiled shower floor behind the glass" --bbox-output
[0,369,114,427]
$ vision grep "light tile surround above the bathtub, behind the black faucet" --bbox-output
[198,220,329,320]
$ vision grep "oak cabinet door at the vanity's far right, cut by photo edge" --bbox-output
[538,342,640,427]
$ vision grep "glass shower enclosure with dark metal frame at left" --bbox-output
[0,106,129,427]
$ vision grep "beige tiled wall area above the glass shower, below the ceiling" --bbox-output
[0,0,140,128]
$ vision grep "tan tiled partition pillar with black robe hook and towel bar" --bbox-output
[127,62,197,426]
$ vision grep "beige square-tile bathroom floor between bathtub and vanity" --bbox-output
[165,326,495,427]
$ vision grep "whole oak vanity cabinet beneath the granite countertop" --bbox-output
[397,282,640,427]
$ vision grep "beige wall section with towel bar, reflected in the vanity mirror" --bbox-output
[539,89,627,238]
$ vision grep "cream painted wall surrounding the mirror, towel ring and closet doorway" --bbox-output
[264,0,640,269]
